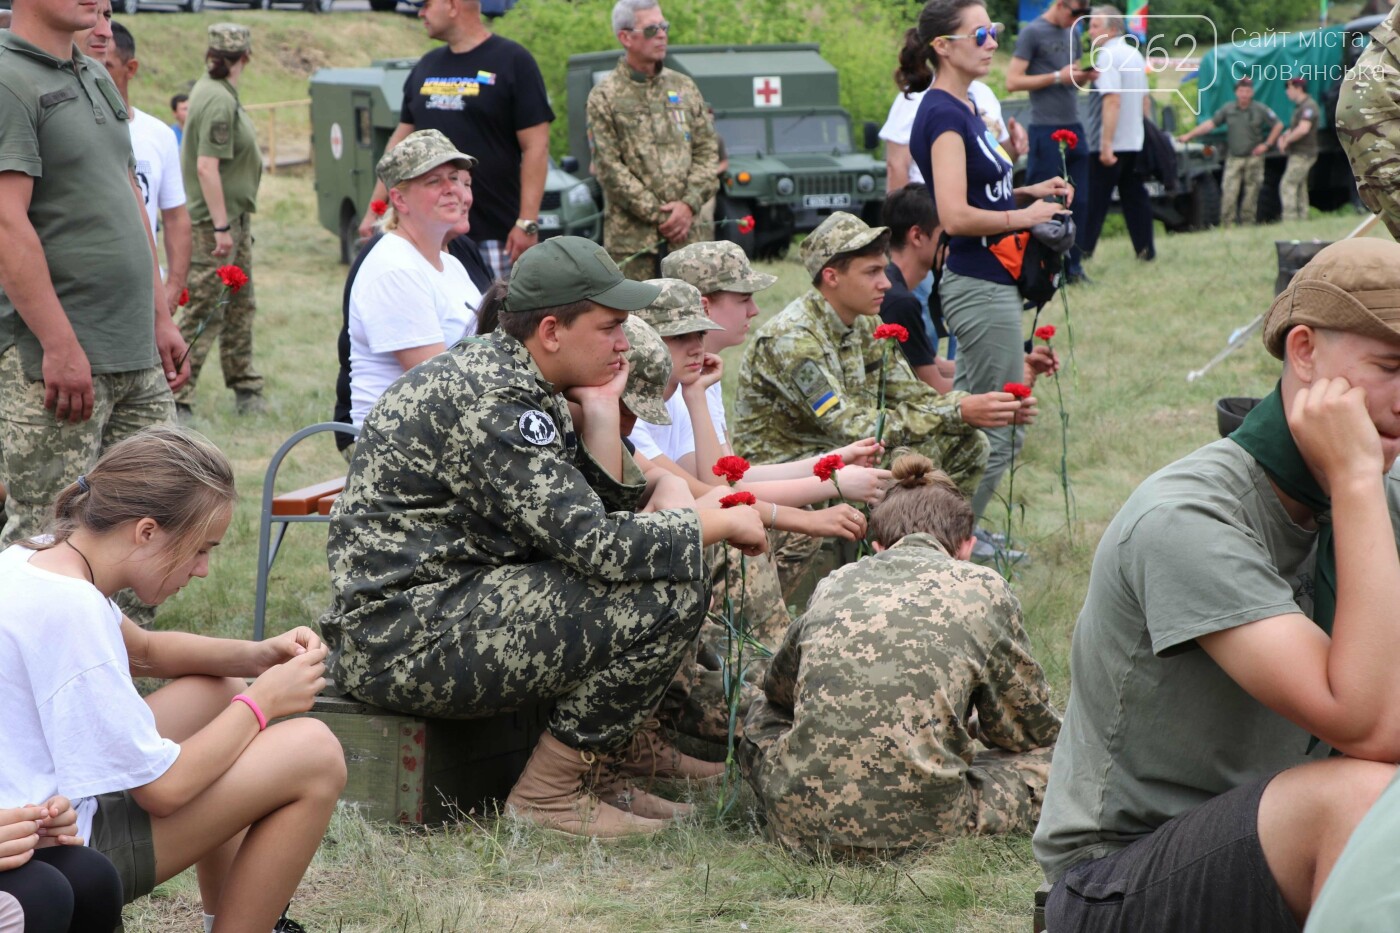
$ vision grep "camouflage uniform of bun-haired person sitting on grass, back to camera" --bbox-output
[741,534,1060,855]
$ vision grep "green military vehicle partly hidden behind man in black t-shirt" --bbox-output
[311,59,602,263]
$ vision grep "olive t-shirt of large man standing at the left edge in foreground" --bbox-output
[0,31,160,380]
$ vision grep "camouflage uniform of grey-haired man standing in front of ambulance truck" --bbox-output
[588,57,720,280]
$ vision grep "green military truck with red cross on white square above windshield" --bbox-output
[567,45,885,256]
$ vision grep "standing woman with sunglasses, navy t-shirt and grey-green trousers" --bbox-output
[896,0,1071,544]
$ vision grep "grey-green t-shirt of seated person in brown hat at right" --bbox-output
[1035,440,1400,881]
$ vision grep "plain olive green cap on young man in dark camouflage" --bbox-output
[501,237,661,314]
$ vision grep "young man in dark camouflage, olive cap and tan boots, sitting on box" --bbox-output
[321,237,766,836]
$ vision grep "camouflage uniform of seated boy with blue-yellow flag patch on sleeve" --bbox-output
[734,290,990,496]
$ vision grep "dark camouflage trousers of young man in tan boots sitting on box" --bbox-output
[347,562,710,751]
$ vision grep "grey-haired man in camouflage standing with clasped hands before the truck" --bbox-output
[588,0,720,280]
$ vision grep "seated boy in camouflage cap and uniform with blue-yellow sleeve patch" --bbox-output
[734,212,996,495]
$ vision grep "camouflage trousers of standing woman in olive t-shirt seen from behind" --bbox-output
[175,214,263,405]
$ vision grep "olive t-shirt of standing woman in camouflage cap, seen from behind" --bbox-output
[181,74,262,223]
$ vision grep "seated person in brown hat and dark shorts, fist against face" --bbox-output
[1035,240,1400,933]
